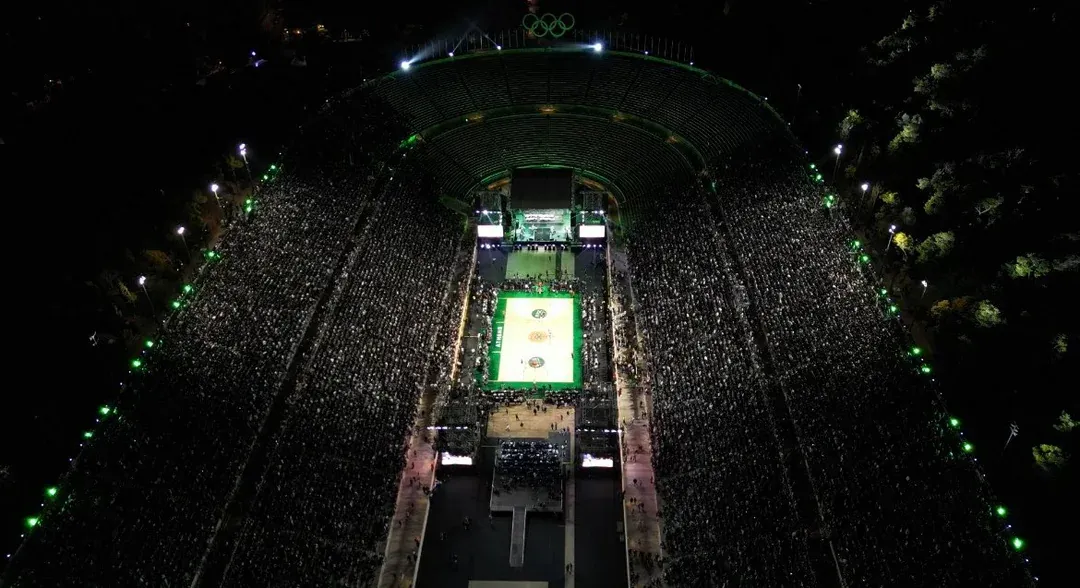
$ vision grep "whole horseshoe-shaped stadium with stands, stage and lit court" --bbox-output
[2,24,1032,588]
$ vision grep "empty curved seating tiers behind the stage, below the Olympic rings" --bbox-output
[366,46,791,196]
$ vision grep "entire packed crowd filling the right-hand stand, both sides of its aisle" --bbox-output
[616,143,1027,586]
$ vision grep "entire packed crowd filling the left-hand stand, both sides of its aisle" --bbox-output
[4,96,462,586]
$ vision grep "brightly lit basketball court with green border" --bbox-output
[488,292,581,389]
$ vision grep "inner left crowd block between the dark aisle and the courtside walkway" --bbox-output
[225,158,463,586]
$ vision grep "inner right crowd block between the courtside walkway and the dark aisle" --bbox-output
[624,183,813,586]
